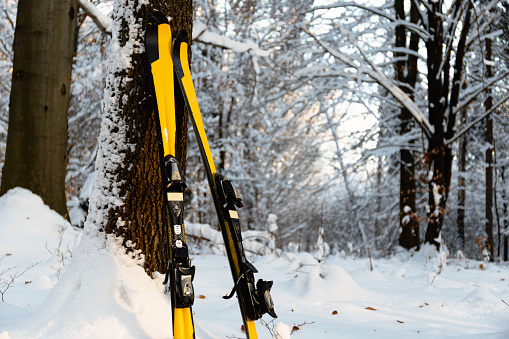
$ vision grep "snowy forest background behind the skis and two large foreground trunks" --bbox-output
[0,0,509,260]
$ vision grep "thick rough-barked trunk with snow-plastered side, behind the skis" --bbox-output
[89,0,192,272]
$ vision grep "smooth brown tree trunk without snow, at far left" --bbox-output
[0,0,78,216]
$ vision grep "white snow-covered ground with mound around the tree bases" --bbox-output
[0,189,509,339]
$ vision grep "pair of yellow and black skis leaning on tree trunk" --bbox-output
[145,12,276,339]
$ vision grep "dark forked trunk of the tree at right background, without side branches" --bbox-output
[425,1,472,248]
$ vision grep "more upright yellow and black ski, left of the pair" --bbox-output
[145,12,195,339]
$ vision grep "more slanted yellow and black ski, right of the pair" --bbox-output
[172,31,276,339]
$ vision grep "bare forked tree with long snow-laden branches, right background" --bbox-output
[304,0,506,250]
